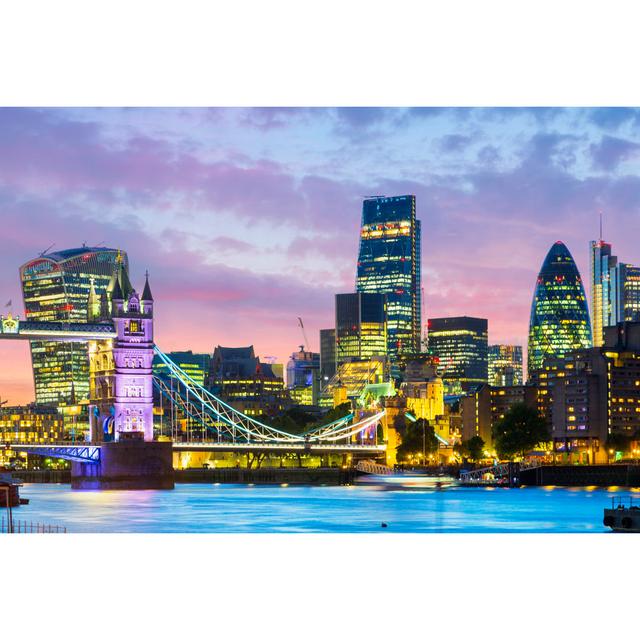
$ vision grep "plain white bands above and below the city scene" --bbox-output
[0,0,640,639]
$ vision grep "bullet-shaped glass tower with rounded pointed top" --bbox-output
[528,241,592,374]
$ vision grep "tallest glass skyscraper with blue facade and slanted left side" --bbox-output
[356,195,421,363]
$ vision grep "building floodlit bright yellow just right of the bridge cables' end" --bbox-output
[400,353,445,422]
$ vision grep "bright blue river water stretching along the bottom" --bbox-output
[14,484,630,534]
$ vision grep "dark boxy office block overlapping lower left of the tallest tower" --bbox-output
[335,293,388,366]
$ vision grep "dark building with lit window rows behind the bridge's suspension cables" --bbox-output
[208,345,291,416]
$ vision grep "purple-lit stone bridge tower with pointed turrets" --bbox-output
[89,274,154,443]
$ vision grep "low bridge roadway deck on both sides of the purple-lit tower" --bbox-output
[4,442,387,464]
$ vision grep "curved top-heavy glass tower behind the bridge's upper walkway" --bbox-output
[20,247,131,405]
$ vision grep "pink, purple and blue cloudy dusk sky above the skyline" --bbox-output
[0,107,640,404]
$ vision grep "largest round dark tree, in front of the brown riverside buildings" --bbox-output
[491,402,550,459]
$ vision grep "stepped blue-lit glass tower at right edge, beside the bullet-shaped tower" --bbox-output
[591,240,640,347]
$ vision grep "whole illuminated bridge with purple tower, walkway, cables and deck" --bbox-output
[0,276,386,484]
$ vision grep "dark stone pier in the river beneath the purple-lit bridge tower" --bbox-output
[71,440,174,489]
